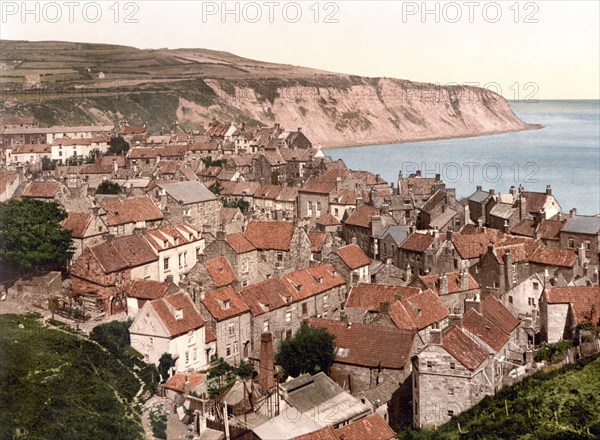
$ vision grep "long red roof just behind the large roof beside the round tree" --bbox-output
[346,283,421,312]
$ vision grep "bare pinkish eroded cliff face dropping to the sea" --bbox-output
[198,78,529,147]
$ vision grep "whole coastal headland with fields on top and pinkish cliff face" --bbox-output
[0,41,532,147]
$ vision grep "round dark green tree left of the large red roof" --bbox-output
[275,325,335,377]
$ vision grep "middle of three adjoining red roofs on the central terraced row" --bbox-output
[240,278,294,316]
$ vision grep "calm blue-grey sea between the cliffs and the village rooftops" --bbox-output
[325,100,600,214]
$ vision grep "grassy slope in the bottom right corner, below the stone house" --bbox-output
[400,357,600,440]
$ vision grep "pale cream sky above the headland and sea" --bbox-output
[0,0,600,101]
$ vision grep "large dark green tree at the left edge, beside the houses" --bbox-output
[0,199,73,273]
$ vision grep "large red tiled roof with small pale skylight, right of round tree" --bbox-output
[308,318,415,369]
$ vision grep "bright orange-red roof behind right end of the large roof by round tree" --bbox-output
[390,289,448,330]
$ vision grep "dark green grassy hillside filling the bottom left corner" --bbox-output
[0,315,144,440]
